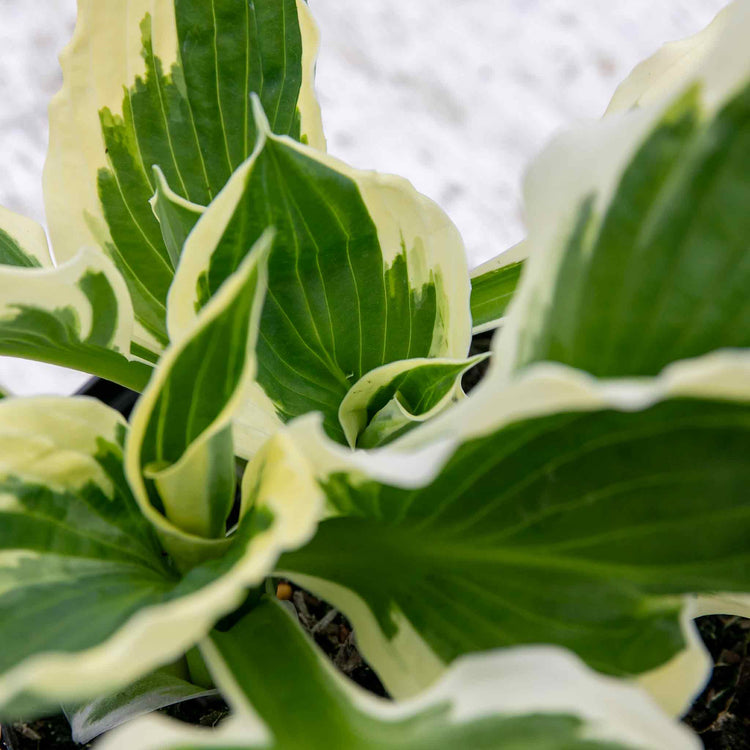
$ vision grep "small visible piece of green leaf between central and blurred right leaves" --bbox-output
[471,244,527,334]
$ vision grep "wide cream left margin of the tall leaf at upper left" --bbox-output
[42,0,160,352]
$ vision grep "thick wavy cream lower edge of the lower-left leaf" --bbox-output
[0,424,323,716]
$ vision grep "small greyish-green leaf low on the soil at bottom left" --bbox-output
[66,669,216,745]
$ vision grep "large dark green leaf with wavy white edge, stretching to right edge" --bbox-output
[279,354,750,708]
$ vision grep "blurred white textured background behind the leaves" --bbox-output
[0,0,726,394]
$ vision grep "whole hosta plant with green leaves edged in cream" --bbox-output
[0,0,750,750]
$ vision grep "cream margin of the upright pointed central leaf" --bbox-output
[167,96,471,359]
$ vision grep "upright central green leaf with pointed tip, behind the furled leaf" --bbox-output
[168,100,471,452]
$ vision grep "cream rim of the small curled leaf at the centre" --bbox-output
[339,354,490,448]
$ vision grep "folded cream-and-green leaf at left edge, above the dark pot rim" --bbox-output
[0,209,151,390]
